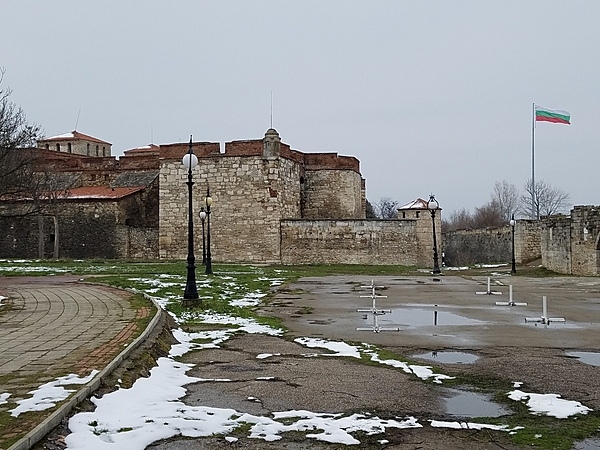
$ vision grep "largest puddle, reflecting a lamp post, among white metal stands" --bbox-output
[378,308,484,327]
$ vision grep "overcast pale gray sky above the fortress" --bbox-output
[0,0,600,214]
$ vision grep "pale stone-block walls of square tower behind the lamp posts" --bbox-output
[159,155,300,263]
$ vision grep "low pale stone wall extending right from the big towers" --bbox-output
[281,219,422,265]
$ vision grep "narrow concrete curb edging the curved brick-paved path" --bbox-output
[8,292,167,450]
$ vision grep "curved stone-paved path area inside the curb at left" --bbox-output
[0,277,136,376]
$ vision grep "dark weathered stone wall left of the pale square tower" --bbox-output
[0,188,158,259]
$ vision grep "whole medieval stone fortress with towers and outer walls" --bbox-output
[0,128,600,275]
